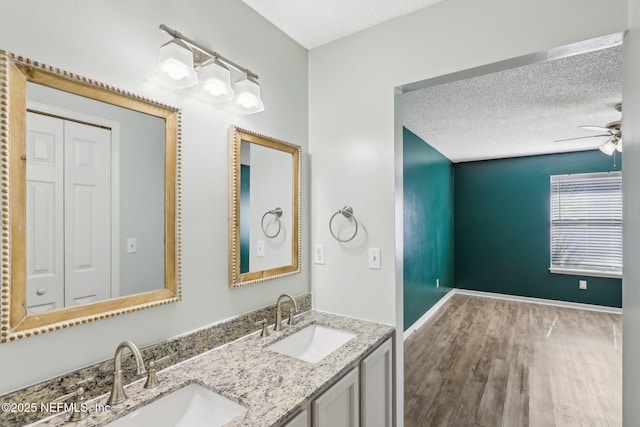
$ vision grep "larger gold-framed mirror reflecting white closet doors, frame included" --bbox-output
[0,51,181,343]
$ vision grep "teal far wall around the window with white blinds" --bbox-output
[452,150,622,307]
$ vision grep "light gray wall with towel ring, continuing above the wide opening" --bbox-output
[309,0,628,425]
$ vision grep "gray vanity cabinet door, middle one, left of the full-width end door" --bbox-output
[313,367,360,427]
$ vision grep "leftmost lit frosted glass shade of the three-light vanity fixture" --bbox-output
[153,39,198,89]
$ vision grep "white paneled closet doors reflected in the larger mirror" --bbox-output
[26,112,112,313]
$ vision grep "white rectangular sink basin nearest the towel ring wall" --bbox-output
[267,324,356,363]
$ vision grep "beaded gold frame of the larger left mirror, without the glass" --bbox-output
[0,50,182,343]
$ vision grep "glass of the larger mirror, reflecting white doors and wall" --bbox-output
[26,82,165,313]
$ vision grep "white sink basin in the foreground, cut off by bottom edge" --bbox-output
[108,383,247,427]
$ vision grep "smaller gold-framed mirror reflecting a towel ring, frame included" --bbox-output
[229,126,301,288]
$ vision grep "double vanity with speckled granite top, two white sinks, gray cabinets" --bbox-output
[28,311,394,427]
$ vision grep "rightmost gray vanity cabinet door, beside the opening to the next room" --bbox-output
[360,338,393,427]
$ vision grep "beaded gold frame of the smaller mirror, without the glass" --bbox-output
[229,125,302,288]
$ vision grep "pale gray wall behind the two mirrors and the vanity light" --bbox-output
[0,0,309,394]
